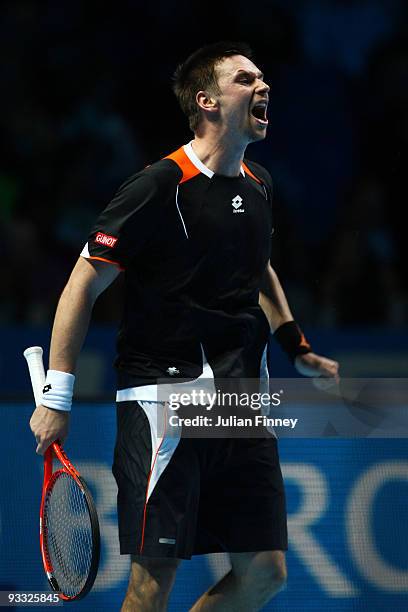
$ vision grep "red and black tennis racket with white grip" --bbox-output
[24,346,100,601]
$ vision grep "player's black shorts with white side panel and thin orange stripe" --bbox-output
[113,400,287,559]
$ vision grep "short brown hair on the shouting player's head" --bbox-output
[173,41,253,132]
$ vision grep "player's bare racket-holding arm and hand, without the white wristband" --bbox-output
[30,257,120,455]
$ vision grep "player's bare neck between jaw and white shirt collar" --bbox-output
[192,135,246,176]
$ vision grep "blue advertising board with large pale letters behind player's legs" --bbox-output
[0,403,408,612]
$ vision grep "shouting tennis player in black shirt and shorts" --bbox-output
[30,42,338,612]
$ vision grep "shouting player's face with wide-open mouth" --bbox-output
[215,55,269,142]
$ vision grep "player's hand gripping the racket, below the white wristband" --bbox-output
[30,406,70,455]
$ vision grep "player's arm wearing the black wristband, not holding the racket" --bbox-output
[259,262,339,382]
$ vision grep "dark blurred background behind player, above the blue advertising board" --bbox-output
[0,0,408,391]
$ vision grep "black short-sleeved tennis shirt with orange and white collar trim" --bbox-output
[82,144,272,388]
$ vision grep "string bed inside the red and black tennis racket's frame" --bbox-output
[44,472,93,596]
